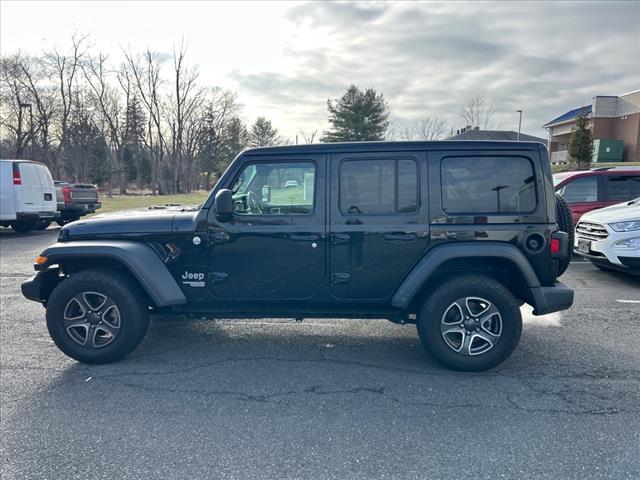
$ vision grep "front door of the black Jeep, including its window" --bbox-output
[208,155,326,301]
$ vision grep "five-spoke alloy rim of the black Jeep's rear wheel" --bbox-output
[440,297,502,356]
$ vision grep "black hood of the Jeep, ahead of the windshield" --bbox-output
[60,207,199,239]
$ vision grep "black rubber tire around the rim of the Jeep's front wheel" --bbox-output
[47,270,149,364]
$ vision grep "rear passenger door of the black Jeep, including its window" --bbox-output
[329,151,429,300]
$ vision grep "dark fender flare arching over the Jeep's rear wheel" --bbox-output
[391,242,540,309]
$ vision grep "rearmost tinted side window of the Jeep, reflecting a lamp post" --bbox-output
[441,157,536,213]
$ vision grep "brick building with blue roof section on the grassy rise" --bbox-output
[543,90,640,163]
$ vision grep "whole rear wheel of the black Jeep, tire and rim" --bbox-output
[417,275,522,371]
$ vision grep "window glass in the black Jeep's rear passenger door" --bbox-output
[339,159,418,215]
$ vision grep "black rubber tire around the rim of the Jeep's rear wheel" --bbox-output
[417,274,522,372]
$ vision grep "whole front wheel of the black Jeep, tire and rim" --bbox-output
[47,270,149,363]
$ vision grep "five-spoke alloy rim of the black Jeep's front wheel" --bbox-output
[63,291,122,348]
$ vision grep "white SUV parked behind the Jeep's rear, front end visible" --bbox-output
[573,197,640,275]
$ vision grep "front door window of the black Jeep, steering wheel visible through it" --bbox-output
[232,162,316,215]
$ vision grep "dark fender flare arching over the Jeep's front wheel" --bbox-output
[42,240,187,307]
